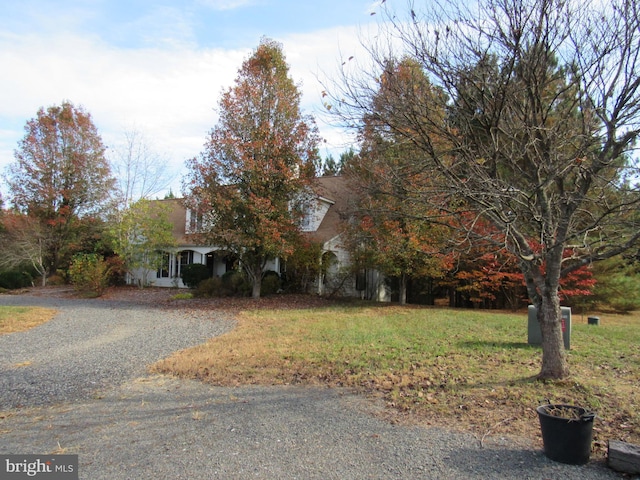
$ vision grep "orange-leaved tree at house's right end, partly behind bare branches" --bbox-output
[344,58,448,304]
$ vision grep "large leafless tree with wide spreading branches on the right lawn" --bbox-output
[329,0,640,378]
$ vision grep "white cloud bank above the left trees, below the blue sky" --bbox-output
[0,30,247,189]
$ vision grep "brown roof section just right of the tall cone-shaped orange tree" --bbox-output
[308,176,352,243]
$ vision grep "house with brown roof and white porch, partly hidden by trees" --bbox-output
[130,176,385,299]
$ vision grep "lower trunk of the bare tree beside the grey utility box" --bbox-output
[536,294,569,379]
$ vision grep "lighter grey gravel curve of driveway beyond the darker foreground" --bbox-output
[0,295,233,410]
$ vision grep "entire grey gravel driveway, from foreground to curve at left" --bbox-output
[0,295,621,480]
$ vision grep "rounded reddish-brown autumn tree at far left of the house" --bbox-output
[6,102,114,282]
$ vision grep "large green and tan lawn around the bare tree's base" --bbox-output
[154,306,640,451]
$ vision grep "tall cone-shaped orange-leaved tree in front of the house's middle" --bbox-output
[184,39,318,298]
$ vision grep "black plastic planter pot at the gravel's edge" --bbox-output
[537,405,596,465]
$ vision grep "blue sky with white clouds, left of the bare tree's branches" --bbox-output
[0,0,380,199]
